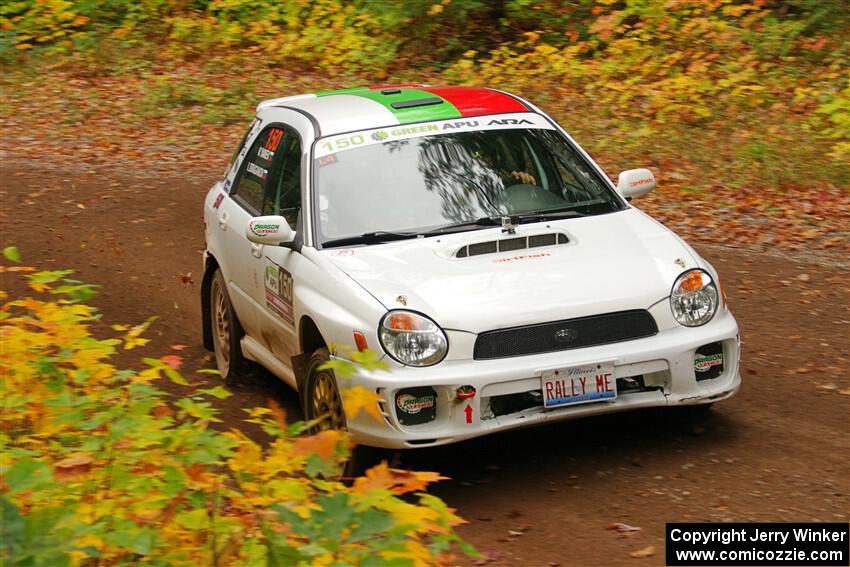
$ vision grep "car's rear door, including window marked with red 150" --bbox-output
[217,125,283,338]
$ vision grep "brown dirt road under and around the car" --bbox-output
[0,162,850,565]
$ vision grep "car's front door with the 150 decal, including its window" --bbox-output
[252,125,304,369]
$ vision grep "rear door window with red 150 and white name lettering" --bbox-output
[232,126,284,214]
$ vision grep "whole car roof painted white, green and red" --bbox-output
[257,84,533,137]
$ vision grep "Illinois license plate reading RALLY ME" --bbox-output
[542,362,617,409]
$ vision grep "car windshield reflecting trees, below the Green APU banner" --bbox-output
[315,120,622,243]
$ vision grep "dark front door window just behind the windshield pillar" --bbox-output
[262,127,301,228]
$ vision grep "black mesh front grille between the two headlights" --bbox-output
[473,309,658,360]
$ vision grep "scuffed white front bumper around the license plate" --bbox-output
[340,309,741,449]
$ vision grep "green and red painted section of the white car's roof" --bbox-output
[316,85,529,124]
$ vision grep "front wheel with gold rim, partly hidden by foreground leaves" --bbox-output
[302,348,390,480]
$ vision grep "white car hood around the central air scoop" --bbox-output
[323,209,697,333]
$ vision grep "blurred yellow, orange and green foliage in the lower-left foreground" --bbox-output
[0,255,470,565]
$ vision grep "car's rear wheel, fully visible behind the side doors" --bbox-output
[209,269,246,384]
